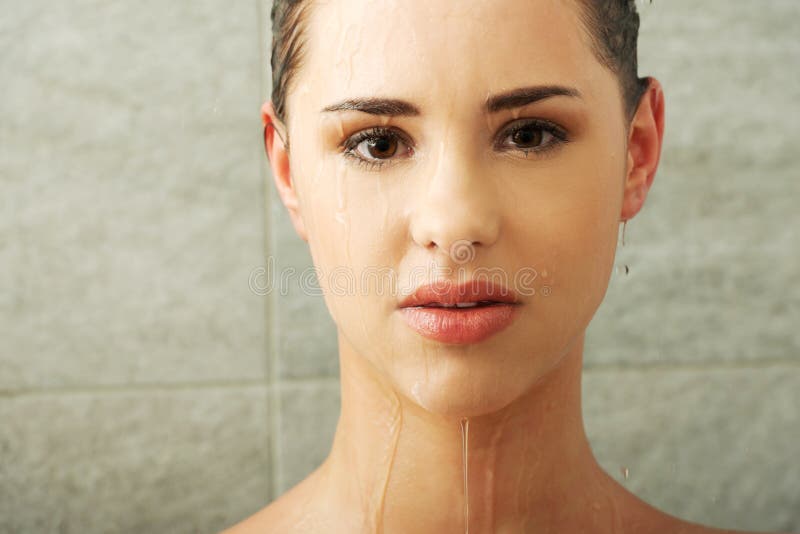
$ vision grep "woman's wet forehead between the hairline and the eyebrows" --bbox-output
[296,0,600,115]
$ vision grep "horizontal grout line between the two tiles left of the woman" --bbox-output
[0,380,265,397]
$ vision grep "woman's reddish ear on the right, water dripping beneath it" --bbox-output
[620,77,664,221]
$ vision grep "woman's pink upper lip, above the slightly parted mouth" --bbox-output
[400,278,519,308]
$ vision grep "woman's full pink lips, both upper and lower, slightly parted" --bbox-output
[399,279,521,344]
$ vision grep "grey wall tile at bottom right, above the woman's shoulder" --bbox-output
[583,366,800,532]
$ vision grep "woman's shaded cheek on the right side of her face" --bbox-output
[506,136,625,330]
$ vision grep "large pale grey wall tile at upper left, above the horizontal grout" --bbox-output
[0,0,266,389]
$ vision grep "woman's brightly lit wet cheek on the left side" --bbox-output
[298,165,405,326]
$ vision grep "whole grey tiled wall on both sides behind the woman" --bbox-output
[0,0,800,533]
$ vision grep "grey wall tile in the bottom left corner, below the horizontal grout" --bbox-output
[0,387,270,534]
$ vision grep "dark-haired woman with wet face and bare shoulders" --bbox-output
[229,0,776,534]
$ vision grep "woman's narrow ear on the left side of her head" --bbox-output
[261,101,308,241]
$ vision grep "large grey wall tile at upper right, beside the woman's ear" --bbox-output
[586,0,800,366]
